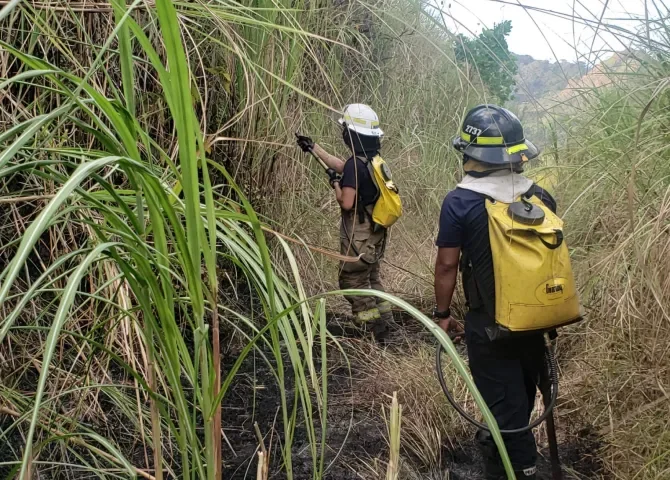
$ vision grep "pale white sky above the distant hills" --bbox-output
[433,0,653,62]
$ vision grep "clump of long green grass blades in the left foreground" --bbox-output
[0,2,334,479]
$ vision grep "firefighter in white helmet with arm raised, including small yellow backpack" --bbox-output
[298,103,401,342]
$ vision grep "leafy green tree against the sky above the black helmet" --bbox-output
[454,20,518,103]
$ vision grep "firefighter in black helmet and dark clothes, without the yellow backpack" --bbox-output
[434,105,556,480]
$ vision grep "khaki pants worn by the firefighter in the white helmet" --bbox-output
[339,212,393,324]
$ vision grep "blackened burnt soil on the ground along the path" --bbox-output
[223,317,605,480]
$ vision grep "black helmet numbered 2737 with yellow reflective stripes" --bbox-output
[452,105,540,165]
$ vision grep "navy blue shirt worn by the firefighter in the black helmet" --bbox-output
[435,185,556,318]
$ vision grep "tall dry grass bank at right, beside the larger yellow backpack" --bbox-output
[502,5,670,479]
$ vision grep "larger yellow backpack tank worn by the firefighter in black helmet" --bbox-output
[486,196,581,332]
